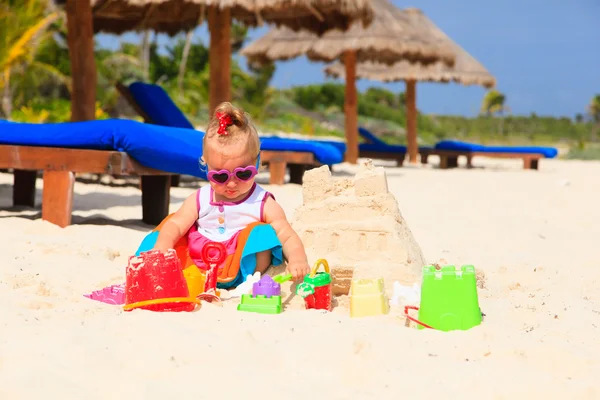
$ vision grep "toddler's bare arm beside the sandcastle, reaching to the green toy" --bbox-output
[264,196,310,280]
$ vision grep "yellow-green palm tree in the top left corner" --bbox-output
[0,0,60,119]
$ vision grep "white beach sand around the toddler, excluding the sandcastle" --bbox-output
[0,160,600,400]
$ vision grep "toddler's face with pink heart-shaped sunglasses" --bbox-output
[206,146,256,202]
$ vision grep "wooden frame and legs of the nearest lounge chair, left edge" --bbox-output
[0,145,171,227]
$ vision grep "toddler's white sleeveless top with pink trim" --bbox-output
[196,183,275,242]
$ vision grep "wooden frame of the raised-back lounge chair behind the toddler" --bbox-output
[116,82,322,186]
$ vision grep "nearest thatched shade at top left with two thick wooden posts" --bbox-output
[55,0,373,120]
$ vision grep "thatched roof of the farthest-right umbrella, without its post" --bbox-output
[325,9,496,88]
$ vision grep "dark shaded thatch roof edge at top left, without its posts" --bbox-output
[55,0,373,35]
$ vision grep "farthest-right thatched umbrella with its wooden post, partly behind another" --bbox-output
[325,8,496,163]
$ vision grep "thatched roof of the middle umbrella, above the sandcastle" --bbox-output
[241,0,454,65]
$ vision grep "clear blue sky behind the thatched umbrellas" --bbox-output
[97,0,600,118]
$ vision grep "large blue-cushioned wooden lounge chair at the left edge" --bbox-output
[0,119,206,227]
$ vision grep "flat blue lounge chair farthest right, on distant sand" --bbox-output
[431,140,558,169]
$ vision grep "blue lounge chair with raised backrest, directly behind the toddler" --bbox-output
[117,82,344,184]
